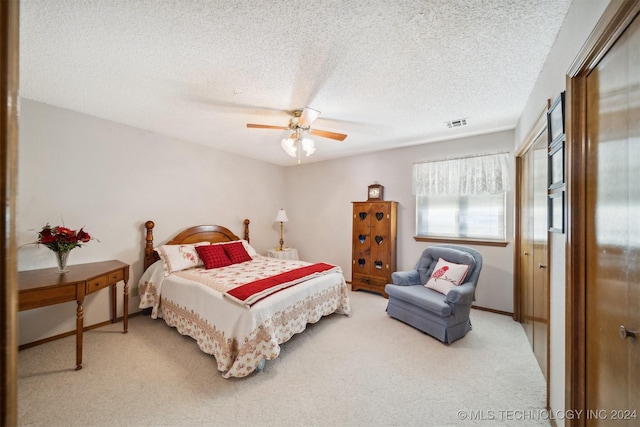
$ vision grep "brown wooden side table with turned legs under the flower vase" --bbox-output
[18,260,129,370]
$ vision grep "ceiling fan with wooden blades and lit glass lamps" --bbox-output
[247,107,347,163]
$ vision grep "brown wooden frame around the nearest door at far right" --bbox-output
[565,0,640,426]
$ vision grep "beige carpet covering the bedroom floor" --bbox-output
[18,292,550,426]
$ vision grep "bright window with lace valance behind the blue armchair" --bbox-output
[413,154,509,241]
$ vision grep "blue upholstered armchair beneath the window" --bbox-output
[385,245,482,344]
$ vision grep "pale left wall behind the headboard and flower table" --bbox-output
[16,99,285,348]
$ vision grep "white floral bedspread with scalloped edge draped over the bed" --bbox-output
[138,256,350,378]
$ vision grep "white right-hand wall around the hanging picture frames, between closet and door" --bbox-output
[515,0,609,426]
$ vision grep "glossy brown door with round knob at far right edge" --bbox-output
[585,10,640,426]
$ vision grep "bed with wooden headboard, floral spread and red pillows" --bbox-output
[138,219,350,378]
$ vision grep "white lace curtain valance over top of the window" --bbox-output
[413,153,510,196]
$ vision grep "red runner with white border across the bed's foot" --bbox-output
[225,262,338,306]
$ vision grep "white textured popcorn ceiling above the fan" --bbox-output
[20,0,571,165]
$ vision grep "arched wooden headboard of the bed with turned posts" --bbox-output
[144,219,251,270]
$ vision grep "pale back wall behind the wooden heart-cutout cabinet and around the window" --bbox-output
[284,131,514,312]
